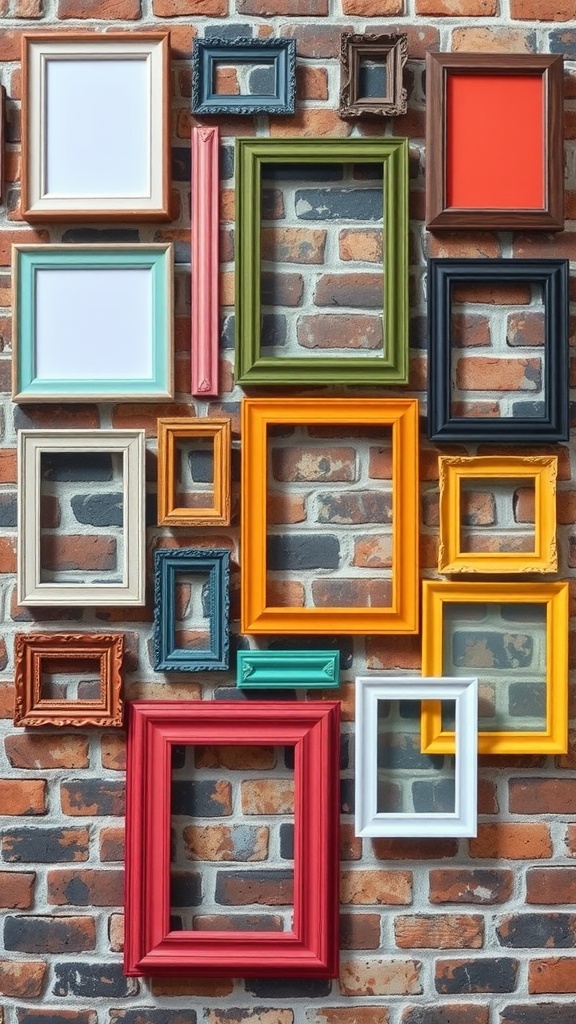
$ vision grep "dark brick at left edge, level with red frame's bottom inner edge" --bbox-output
[4,914,96,953]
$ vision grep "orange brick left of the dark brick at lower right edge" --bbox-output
[394,913,484,949]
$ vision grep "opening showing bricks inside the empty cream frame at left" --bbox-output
[40,450,125,600]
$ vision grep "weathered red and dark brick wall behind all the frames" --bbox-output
[0,0,576,1024]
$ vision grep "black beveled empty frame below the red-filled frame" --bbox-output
[426,257,570,444]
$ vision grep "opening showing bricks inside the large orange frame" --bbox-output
[266,425,394,608]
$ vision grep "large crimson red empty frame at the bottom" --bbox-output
[124,700,340,978]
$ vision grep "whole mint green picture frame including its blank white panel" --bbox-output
[12,244,173,403]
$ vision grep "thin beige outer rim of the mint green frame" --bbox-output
[11,242,174,404]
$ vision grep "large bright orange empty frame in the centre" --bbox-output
[241,398,418,634]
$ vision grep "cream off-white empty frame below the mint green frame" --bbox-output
[17,430,146,607]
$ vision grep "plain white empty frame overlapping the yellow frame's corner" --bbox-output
[356,676,478,837]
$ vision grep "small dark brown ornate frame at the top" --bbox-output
[339,32,408,119]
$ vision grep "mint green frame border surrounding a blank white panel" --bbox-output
[12,244,173,403]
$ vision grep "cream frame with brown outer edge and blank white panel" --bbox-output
[22,31,170,220]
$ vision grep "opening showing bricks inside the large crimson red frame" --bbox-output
[170,743,294,932]
